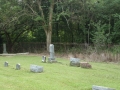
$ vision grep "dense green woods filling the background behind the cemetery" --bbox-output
[0,0,120,52]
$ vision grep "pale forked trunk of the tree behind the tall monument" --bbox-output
[37,0,54,51]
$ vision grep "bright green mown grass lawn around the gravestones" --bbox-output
[0,55,120,90]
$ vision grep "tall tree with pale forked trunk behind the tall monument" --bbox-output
[21,0,55,50]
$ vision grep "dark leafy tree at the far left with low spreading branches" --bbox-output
[0,0,29,52]
